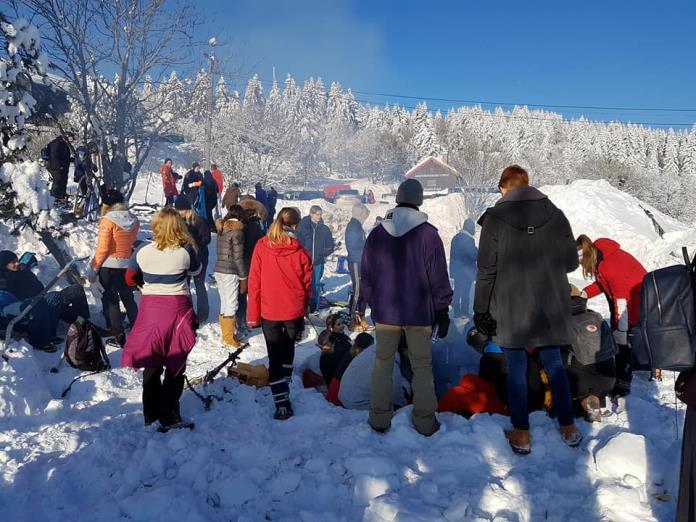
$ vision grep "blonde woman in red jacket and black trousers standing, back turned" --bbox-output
[247,207,312,420]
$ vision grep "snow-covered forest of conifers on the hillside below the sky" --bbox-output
[143,70,696,222]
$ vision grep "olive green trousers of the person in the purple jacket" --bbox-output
[369,323,440,436]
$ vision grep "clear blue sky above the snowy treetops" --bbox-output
[199,0,696,128]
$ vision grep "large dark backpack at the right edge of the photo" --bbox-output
[629,247,696,371]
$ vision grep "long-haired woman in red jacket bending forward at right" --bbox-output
[576,234,647,402]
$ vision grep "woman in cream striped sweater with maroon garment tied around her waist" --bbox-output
[121,207,202,430]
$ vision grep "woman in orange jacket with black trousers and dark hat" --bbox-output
[87,189,140,347]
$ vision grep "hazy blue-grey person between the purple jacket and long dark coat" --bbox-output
[450,219,478,317]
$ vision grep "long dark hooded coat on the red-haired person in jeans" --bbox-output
[474,187,578,348]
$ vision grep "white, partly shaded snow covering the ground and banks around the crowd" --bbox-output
[0,176,696,522]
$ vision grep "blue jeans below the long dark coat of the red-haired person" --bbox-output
[503,346,575,430]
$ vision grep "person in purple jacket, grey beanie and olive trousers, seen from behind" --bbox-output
[361,179,453,436]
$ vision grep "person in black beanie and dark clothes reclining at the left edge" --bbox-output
[0,250,89,324]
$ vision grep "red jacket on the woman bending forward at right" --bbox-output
[585,238,647,331]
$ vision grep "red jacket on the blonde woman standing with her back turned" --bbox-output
[247,237,312,327]
